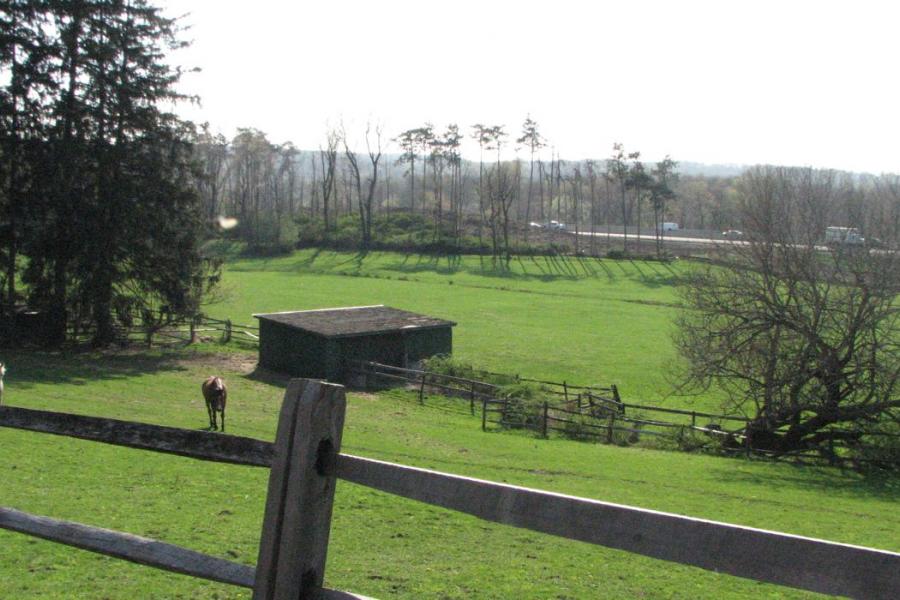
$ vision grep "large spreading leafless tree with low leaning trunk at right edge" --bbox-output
[676,167,900,457]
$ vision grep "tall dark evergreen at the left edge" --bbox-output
[2,0,214,345]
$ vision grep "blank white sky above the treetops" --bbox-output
[159,0,900,173]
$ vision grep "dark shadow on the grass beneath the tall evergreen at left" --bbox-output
[0,350,187,389]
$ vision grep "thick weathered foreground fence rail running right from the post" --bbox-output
[337,454,900,598]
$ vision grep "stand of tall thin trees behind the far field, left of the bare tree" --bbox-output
[196,122,679,256]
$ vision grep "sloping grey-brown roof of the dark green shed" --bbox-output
[253,304,456,338]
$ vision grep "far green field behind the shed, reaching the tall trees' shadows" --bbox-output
[207,250,720,410]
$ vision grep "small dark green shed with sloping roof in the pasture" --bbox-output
[253,305,456,382]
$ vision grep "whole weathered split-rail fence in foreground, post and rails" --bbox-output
[0,379,900,600]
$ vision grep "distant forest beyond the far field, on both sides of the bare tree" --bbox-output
[195,124,900,255]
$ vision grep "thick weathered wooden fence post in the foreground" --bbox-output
[253,379,346,600]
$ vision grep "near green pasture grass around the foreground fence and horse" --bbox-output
[0,350,900,599]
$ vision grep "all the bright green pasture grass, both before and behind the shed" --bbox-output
[0,247,900,599]
